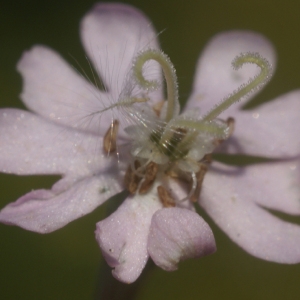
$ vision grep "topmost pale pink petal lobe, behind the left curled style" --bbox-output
[81,3,163,101]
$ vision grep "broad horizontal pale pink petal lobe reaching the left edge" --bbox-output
[0,109,111,177]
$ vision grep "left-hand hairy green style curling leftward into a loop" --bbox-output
[133,49,180,122]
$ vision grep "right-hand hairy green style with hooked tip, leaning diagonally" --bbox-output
[203,52,272,121]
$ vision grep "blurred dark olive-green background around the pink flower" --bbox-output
[0,0,300,300]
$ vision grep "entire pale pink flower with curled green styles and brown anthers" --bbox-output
[0,4,300,282]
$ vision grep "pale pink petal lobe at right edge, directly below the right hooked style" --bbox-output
[219,90,300,158]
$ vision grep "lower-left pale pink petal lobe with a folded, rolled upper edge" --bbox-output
[0,174,122,233]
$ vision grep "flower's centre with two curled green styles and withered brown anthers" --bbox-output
[104,49,272,206]
